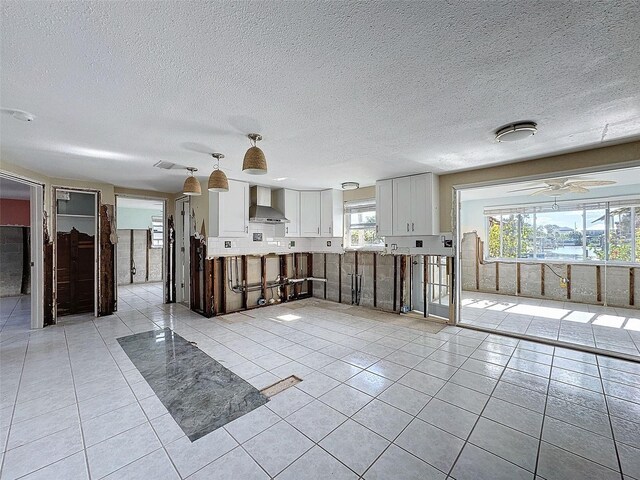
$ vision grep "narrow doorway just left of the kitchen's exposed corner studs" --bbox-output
[175,197,191,306]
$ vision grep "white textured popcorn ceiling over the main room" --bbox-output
[0,0,640,191]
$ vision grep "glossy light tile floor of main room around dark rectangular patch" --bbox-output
[0,285,640,480]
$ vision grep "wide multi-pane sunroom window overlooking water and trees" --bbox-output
[485,199,640,263]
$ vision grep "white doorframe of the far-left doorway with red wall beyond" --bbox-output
[0,171,45,329]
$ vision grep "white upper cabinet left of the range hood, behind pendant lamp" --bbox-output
[209,180,249,237]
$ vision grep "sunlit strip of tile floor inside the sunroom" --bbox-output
[462,291,640,359]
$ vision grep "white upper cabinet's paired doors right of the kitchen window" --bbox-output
[392,173,440,236]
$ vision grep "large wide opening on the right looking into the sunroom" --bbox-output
[454,167,640,360]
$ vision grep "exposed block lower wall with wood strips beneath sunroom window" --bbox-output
[461,232,640,309]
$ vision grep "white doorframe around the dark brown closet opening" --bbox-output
[51,185,102,324]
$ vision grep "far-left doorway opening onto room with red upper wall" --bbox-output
[0,173,44,333]
